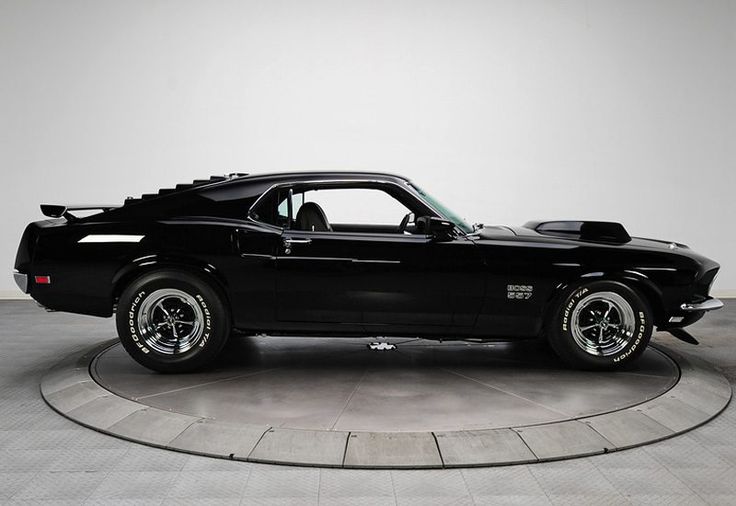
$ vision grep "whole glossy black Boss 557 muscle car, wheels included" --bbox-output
[15,172,722,372]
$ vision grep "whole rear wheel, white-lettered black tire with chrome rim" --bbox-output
[115,270,230,373]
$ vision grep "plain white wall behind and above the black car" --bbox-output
[0,0,736,293]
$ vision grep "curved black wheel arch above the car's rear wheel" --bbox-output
[112,255,232,320]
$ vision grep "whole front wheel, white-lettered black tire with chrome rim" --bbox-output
[547,281,653,370]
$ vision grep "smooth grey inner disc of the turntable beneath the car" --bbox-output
[94,337,678,432]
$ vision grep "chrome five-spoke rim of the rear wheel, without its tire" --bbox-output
[137,288,204,355]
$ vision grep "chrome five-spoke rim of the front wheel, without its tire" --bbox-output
[571,292,636,357]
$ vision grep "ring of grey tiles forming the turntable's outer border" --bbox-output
[41,340,731,469]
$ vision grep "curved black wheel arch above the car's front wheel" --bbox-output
[542,271,665,330]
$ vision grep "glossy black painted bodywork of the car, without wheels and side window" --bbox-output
[15,172,719,338]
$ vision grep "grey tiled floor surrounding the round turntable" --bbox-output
[0,301,736,505]
